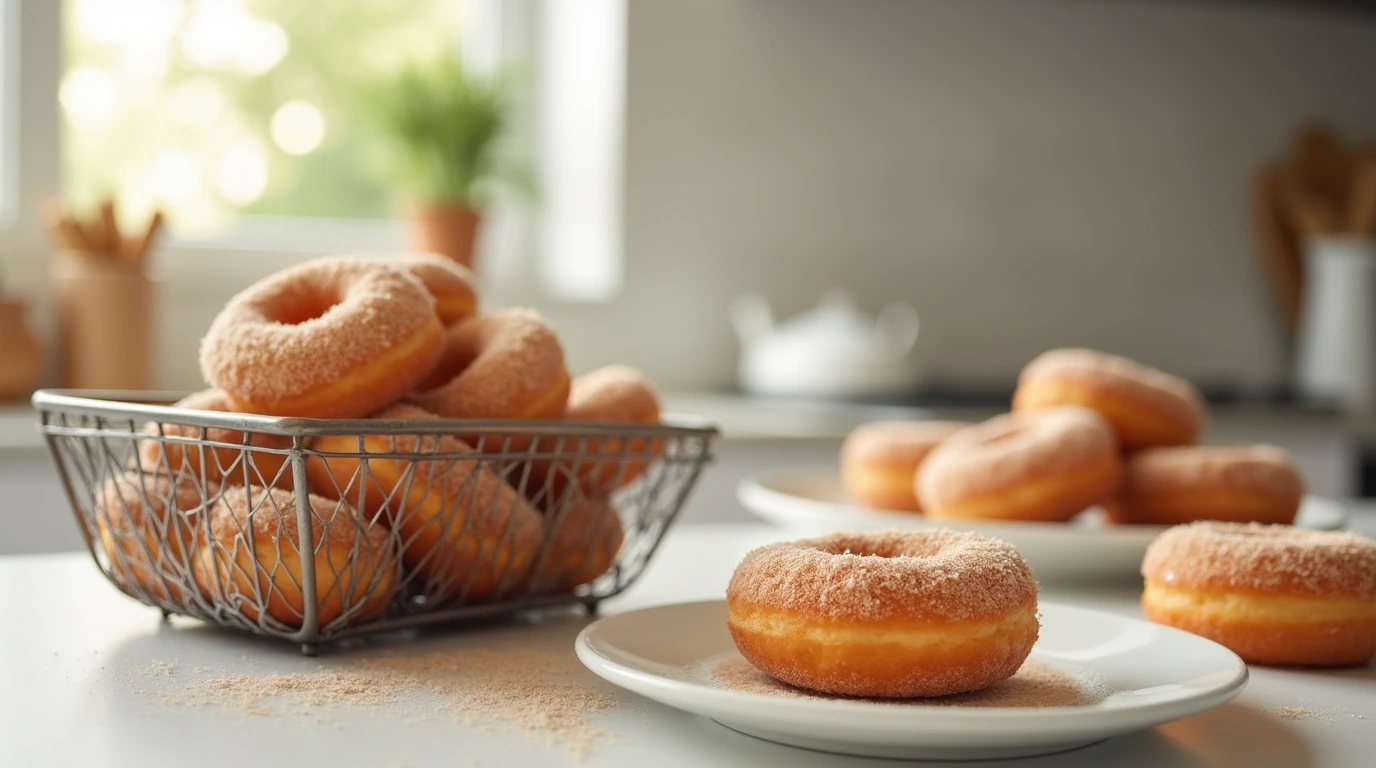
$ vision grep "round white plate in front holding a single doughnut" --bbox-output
[575,600,1247,760]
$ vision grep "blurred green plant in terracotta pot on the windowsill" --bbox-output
[365,55,528,267]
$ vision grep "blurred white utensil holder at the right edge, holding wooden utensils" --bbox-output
[1295,237,1376,413]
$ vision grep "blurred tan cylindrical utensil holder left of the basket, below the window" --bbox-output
[54,252,157,390]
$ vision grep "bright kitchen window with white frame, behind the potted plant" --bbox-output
[0,0,627,309]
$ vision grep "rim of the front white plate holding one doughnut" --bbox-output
[574,599,1251,735]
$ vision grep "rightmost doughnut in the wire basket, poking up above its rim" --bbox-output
[526,365,665,498]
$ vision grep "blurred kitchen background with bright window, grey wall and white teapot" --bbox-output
[0,0,1376,553]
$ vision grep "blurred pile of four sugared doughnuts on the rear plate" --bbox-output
[841,350,1304,524]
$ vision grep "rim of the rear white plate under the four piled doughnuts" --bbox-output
[736,464,1351,544]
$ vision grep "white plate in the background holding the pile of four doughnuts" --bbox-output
[736,467,1347,578]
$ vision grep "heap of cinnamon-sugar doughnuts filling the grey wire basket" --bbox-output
[112,255,659,628]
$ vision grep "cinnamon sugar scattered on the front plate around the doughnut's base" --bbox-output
[698,655,1108,707]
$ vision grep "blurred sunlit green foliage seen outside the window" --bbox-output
[63,0,468,231]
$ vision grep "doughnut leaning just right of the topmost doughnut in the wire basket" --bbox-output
[411,310,570,423]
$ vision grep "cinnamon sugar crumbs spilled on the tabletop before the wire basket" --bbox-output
[135,648,621,758]
